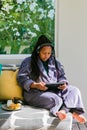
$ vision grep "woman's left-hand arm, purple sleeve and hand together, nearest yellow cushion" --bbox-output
[17,58,47,91]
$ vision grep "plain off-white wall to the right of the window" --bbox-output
[58,0,87,110]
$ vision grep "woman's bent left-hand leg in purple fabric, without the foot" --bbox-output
[24,91,64,116]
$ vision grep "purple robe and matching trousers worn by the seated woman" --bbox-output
[17,57,84,116]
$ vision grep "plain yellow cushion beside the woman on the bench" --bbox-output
[0,70,23,100]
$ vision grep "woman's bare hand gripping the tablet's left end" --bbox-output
[30,82,48,91]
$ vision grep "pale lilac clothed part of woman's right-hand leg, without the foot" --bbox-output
[63,86,85,114]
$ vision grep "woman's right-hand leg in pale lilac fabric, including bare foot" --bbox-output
[64,86,86,123]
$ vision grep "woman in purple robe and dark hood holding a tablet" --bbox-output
[17,35,86,123]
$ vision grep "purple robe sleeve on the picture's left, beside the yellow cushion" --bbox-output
[17,57,34,92]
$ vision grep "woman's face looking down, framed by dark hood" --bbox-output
[39,46,52,61]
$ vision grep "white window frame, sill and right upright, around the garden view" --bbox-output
[0,0,59,64]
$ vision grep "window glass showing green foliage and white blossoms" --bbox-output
[0,0,55,54]
